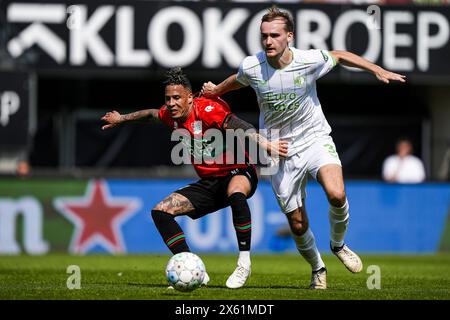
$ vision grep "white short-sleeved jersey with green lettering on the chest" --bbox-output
[237,48,336,155]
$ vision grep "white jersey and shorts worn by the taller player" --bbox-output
[237,48,341,213]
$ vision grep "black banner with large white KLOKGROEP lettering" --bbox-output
[0,0,450,80]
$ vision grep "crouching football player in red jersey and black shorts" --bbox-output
[102,68,287,288]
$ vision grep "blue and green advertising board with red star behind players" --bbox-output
[0,179,450,254]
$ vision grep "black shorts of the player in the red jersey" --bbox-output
[175,166,258,219]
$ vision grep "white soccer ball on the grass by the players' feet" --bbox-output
[166,252,206,292]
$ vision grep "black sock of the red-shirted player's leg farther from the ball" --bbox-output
[228,192,252,251]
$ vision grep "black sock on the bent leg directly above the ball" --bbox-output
[152,210,191,254]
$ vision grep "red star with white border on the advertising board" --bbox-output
[54,180,141,253]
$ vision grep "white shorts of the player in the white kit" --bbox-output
[271,136,342,213]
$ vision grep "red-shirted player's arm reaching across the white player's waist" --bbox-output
[224,114,288,158]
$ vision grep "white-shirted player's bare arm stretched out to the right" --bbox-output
[330,51,406,83]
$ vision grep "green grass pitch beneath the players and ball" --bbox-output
[0,254,450,300]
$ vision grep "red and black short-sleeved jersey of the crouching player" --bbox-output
[159,97,249,178]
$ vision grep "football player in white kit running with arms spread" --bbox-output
[202,7,405,289]
